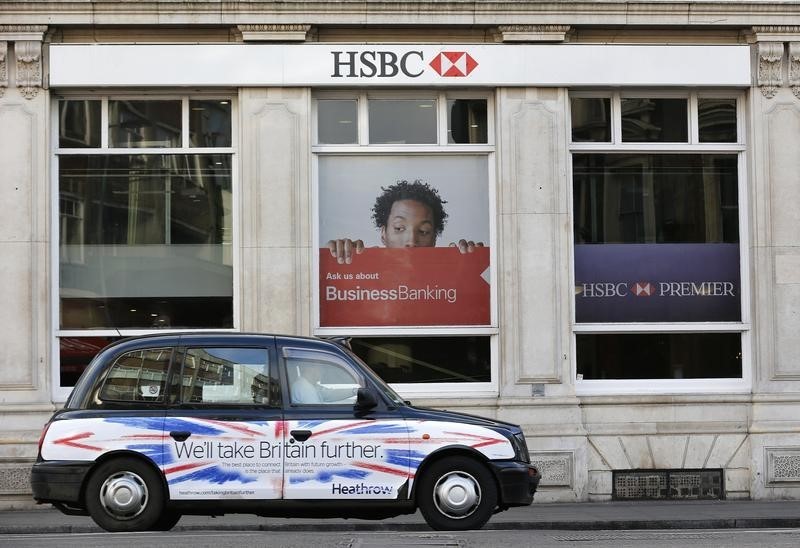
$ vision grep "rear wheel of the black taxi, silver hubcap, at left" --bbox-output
[86,458,166,532]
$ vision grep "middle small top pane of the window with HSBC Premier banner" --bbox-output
[622,99,689,143]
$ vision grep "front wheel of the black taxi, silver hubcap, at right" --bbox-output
[417,457,497,531]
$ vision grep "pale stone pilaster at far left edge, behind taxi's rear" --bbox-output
[0,25,54,508]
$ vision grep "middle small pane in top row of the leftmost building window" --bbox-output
[108,100,181,148]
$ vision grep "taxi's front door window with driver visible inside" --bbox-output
[284,348,364,405]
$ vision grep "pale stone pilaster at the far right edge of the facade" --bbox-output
[748,26,800,498]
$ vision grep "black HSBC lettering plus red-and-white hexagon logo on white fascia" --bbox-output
[331,50,478,78]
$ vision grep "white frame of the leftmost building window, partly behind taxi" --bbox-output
[49,90,241,402]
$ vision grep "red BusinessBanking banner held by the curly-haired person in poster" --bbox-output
[319,247,490,327]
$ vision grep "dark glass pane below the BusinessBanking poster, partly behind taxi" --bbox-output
[350,337,491,383]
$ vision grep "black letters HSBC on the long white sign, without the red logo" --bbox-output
[331,51,424,78]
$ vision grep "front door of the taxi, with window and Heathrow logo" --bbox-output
[279,342,409,500]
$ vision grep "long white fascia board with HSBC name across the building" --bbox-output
[49,43,750,88]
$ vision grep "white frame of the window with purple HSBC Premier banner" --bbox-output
[566,89,752,396]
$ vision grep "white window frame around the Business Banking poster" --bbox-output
[311,88,500,398]
